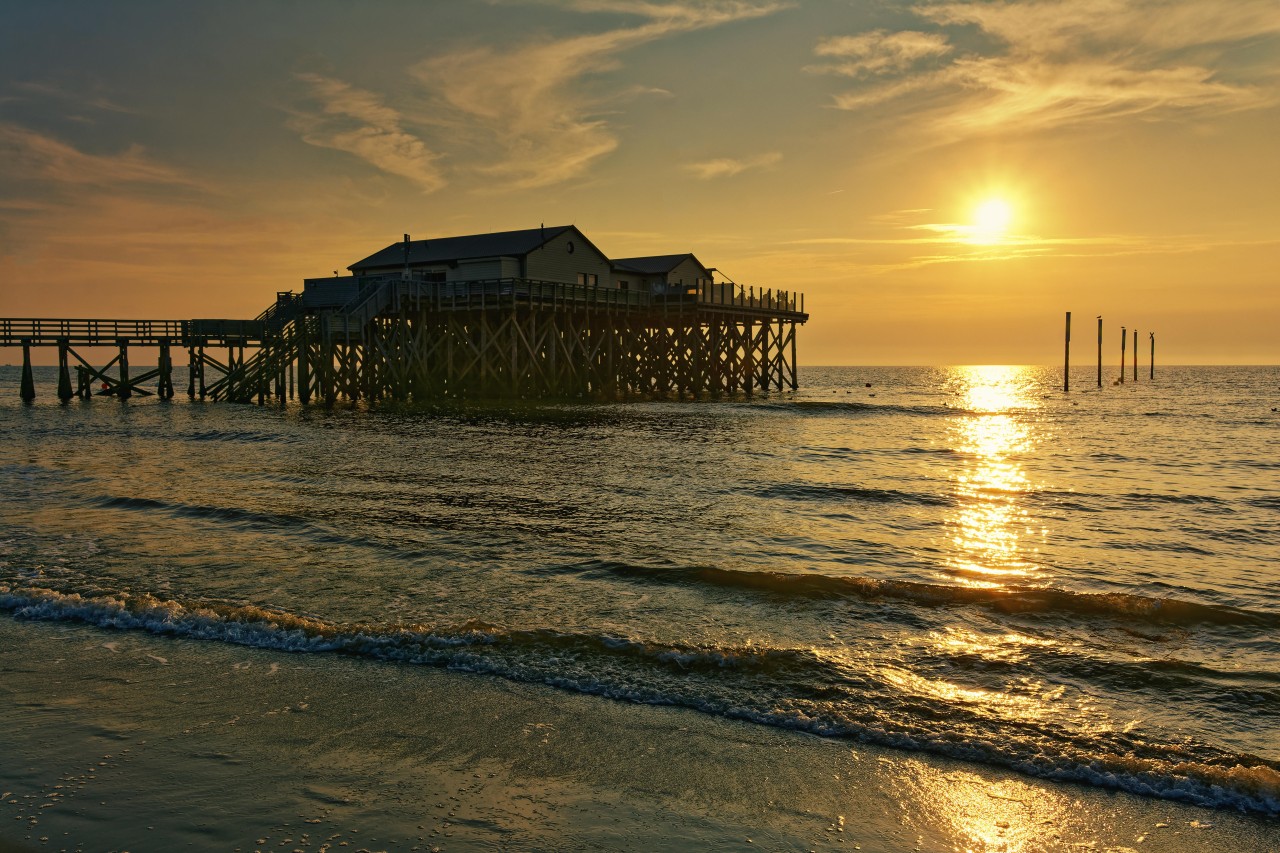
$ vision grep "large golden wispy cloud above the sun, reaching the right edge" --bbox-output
[809,0,1280,136]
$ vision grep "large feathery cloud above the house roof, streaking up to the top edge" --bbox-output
[412,0,785,188]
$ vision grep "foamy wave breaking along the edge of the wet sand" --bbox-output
[0,584,1280,816]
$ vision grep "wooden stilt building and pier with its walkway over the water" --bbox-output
[0,225,809,403]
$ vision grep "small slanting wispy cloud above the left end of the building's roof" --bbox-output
[291,73,447,192]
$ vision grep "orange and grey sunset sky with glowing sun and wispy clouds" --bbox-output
[0,0,1280,365]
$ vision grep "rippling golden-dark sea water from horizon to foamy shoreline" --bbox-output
[0,368,1280,817]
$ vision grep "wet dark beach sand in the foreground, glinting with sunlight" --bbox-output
[0,616,1280,853]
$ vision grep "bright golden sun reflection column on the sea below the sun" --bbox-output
[947,365,1038,588]
